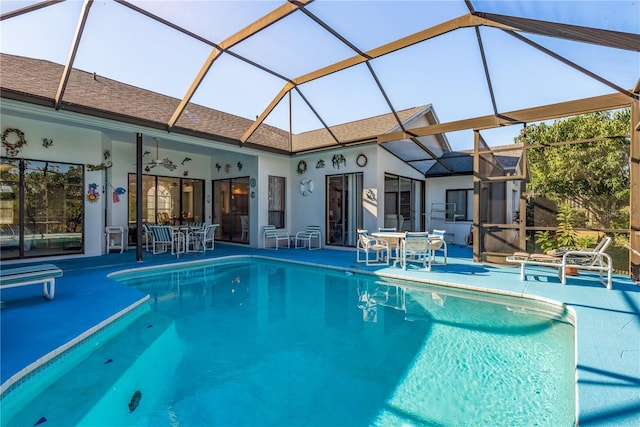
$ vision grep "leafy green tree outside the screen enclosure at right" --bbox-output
[515,109,631,228]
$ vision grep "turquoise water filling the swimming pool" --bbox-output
[2,259,576,427]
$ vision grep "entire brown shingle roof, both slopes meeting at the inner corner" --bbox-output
[0,53,424,156]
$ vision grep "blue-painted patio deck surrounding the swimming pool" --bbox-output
[0,243,640,426]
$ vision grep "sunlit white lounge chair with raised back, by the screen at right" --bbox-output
[507,237,613,289]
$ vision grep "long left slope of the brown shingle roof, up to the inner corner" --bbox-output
[0,53,289,150]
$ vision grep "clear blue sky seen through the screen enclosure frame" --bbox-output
[0,0,640,149]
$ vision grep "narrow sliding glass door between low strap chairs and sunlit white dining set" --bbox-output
[326,173,363,246]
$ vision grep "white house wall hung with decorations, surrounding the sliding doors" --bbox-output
[1,101,456,256]
